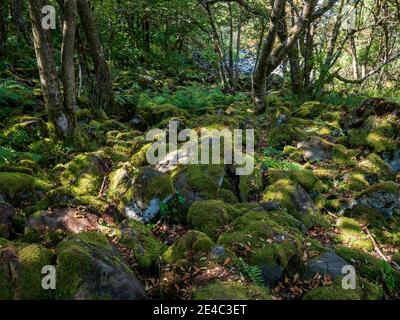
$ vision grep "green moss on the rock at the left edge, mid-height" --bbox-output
[0,172,50,204]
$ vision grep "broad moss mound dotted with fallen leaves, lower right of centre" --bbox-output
[218,211,302,267]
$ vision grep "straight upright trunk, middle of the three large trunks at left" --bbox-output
[61,0,77,126]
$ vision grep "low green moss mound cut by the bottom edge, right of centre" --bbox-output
[193,282,271,300]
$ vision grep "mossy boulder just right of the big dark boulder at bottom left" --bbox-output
[115,220,165,270]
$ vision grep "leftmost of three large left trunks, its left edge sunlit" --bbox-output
[29,0,75,139]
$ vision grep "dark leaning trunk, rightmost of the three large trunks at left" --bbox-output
[78,0,114,110]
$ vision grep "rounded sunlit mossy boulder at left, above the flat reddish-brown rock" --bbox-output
[60,151,110,196]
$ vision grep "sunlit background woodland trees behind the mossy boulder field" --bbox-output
[0,0,400,128]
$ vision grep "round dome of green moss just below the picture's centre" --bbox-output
[187,200,233,240]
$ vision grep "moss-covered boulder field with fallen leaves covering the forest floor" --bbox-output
[0,87,400,300]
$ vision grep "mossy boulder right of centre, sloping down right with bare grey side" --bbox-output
[262,179,329,227]
